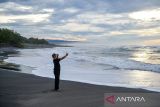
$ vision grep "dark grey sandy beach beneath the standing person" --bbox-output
[0,69,158,107]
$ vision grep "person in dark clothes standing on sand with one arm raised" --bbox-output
[52,53,68,91]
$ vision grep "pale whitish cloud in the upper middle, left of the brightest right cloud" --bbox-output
[67,12,130,25]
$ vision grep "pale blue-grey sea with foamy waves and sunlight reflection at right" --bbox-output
[5,43,160,92]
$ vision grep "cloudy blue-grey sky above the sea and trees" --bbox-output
[0,0,160,45]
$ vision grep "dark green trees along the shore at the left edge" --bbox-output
[0,28,48,47]
